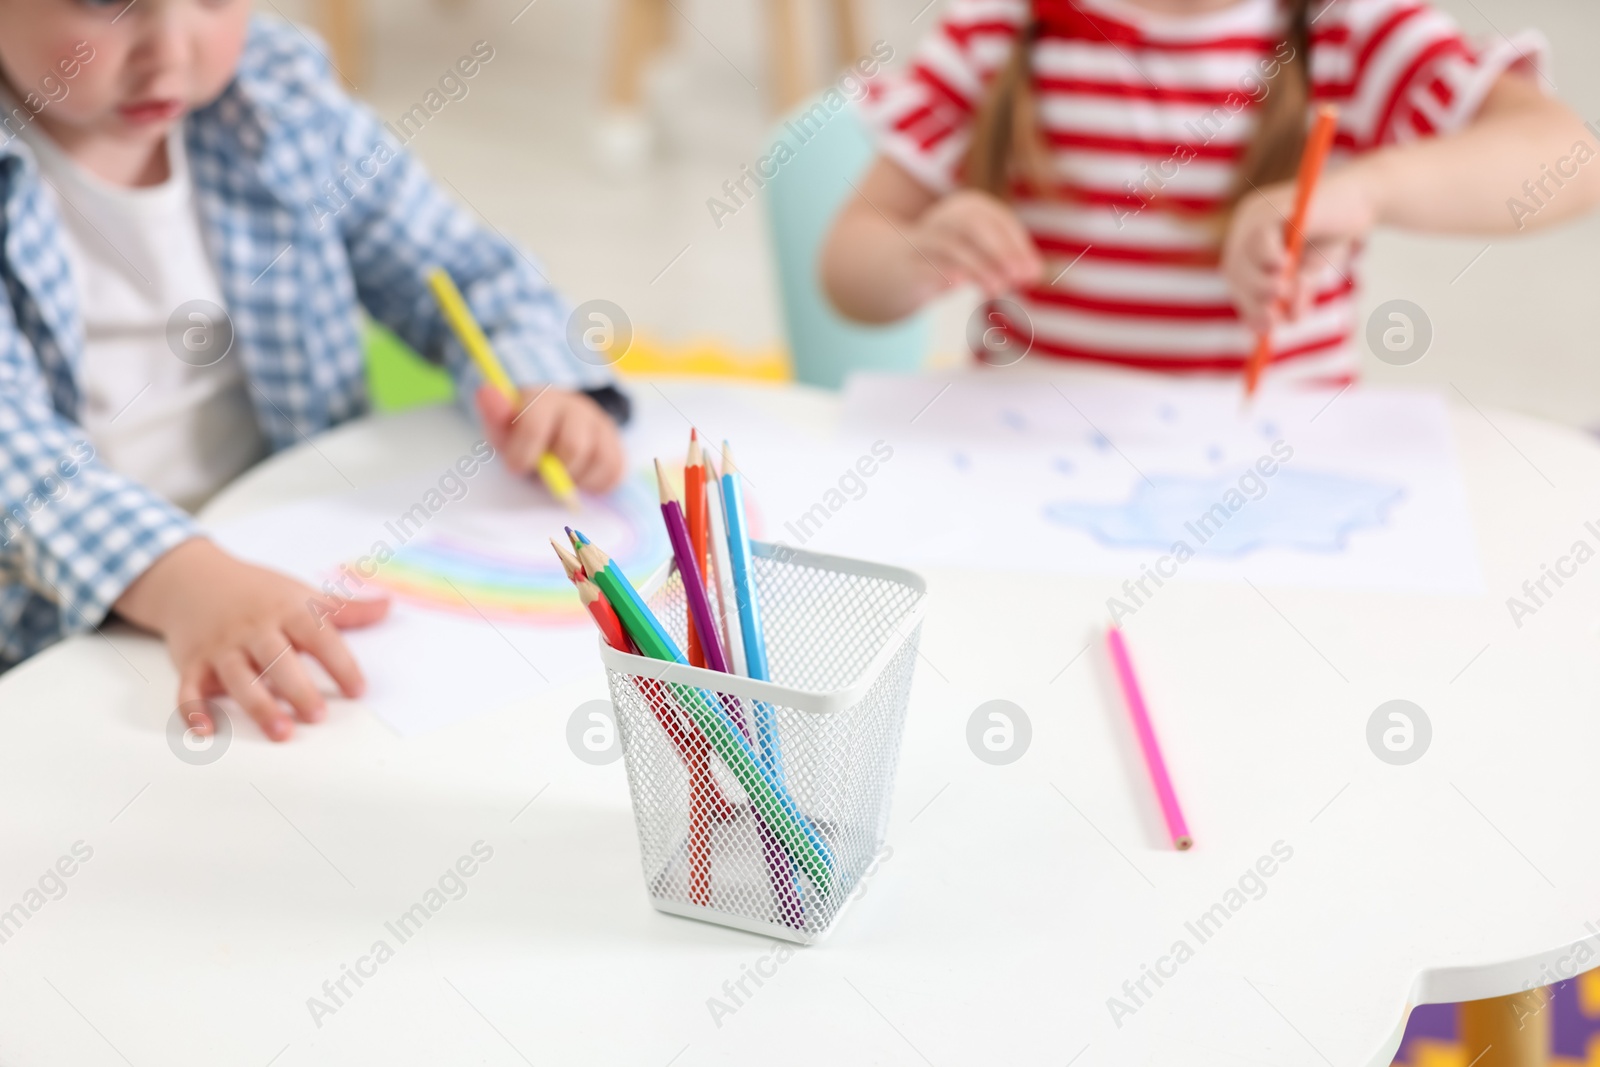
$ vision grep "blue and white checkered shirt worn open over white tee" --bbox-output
[0,19,608,670]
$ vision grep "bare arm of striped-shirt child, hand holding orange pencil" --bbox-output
[1222,74,1600,330]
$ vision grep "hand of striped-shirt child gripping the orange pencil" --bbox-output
[1222,166,1378,333]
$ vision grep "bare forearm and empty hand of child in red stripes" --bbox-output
[821,157,1043,322]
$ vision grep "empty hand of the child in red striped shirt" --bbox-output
[906,189,1045,302]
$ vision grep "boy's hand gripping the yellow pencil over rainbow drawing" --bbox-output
[477,386,624,493]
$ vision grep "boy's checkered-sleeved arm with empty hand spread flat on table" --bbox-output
[0,326,384,741]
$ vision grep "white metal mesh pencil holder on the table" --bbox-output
[600,542,926,942]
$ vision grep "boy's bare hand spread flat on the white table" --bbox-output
[115,537,389,741]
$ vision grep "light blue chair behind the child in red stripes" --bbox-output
[765,101,931,389]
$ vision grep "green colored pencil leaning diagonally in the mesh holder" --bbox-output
[578,544,834,902]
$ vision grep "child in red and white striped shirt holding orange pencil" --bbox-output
[822,0,1600,384]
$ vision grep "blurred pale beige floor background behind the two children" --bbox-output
[268,0,1600,427]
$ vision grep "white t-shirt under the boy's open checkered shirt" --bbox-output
[22,115,266,510]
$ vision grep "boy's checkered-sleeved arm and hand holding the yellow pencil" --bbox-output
[323,77,624,491]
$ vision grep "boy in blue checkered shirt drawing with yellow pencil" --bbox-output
[0,0,624,741]
